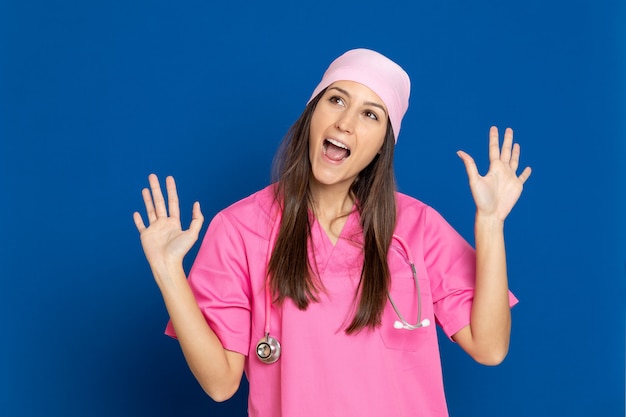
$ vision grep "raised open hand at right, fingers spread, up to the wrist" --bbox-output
[457,126,531,221]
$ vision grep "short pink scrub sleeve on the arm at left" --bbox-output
[165,213,251,355]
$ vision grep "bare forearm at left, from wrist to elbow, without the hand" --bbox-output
[153,266,244,401]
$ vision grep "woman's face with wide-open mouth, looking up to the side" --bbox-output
[309,81,388,192]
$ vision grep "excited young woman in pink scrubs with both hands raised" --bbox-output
[134,49,530,417]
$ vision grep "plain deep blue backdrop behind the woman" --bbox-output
[0,0,626,417]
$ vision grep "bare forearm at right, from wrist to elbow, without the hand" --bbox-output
[455,214,511,365]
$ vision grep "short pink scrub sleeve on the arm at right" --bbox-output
[423,208,518,338]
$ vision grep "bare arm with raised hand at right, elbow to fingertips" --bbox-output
[453,127,531,365]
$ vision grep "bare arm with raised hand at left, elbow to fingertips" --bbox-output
[133,174,245,401]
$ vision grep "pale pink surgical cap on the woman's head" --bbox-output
[309,49,411,142]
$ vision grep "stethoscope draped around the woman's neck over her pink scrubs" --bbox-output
[256,221,430,364]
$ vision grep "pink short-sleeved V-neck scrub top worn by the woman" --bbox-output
[166,186,517,417]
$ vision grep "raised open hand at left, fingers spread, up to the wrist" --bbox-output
[133,174,204,272]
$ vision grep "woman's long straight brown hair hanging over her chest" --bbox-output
[268,90,396,333]
